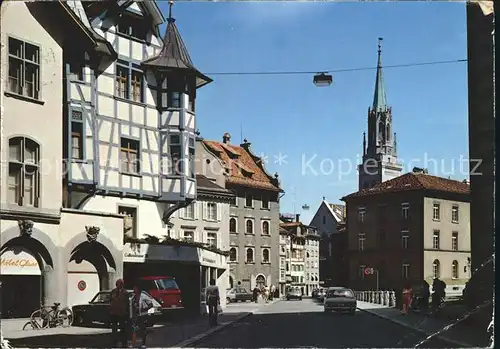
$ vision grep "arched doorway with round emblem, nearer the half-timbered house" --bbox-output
[68,238,116,306]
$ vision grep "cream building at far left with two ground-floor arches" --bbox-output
[0,2,123,318]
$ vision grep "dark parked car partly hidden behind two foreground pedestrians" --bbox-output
[73,290,162,327]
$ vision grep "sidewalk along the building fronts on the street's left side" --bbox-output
[1,302,274,348]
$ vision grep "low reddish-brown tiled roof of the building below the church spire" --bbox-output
[342,172,470,201]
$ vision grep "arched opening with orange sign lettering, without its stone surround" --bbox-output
[0,235,54,318]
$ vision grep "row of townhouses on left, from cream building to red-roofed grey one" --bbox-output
[0,1,283,317]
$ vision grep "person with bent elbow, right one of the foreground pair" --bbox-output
[129,286,153,348]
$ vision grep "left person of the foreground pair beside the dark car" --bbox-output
[109,279,129,347]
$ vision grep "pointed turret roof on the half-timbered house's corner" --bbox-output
[142,1,213,88]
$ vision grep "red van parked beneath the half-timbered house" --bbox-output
[139,276,184,311]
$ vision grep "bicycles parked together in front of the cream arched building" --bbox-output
[23,303,74,330]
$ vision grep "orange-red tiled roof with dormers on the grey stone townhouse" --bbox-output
[203,140,281,191]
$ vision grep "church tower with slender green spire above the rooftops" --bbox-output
[358,38,403,190]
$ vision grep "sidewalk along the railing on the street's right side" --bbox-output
[358,301,489,348]
